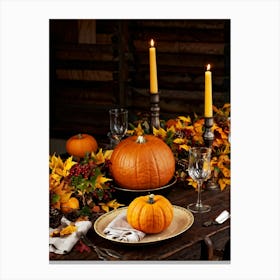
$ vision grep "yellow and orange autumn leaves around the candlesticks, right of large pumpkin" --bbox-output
[128,103,230,190]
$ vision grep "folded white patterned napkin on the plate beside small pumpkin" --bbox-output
[103,211,145,242]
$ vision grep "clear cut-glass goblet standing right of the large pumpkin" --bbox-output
[188,147,211,213]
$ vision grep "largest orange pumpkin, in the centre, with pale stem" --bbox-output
[110,135,175,190]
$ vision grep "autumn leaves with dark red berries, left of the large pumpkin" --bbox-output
[49,149,122,226]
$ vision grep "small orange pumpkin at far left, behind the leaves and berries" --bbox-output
[66,134,98,158]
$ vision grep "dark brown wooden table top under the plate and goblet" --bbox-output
[50,183,230,262]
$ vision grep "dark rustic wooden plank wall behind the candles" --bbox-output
[50,20,230,141]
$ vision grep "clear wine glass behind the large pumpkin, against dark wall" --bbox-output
[109,108,128,146]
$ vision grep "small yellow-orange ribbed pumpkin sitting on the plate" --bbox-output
[126,194,174,233]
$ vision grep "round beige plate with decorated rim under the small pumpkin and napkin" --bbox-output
[94,205,194,245]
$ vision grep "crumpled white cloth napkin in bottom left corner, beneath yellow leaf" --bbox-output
[49,217,92,254]
